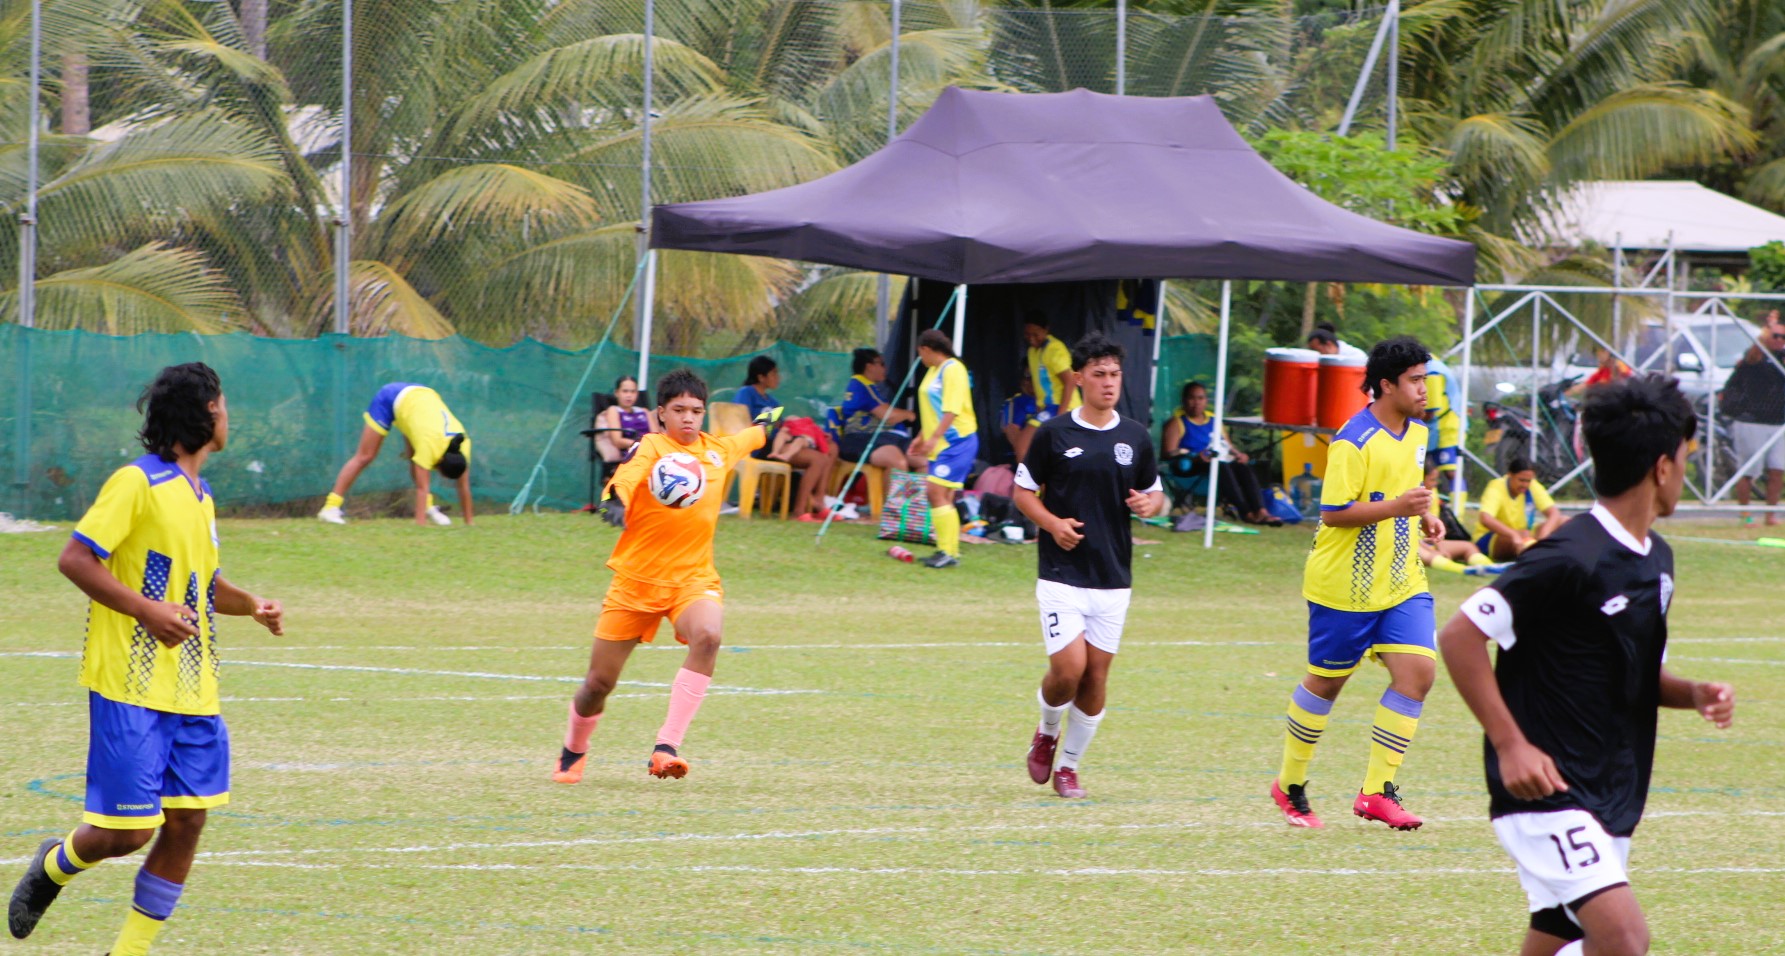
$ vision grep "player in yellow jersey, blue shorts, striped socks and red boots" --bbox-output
[1271,335,1444,829]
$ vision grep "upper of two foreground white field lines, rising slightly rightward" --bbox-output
[0,810,1763,872]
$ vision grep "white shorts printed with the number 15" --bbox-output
[1494,810,1630,919]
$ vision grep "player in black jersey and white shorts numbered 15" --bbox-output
[1439,376,1735,956]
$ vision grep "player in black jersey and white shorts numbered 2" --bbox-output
[1016,332,1166,797]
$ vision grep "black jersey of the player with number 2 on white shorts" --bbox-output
[1016,408,1160,589]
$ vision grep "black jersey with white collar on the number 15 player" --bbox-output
[1462,505,1673,837]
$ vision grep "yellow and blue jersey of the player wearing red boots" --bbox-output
[1301,408,1426,610]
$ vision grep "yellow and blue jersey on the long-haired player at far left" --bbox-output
[75,455,218,717]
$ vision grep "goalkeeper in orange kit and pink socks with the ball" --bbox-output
[552,369,780,783]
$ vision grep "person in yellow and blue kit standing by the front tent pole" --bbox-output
[907,328,985,567]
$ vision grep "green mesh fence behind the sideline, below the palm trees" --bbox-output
[0,325,1214,519]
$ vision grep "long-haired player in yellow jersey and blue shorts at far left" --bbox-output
[7,362,284,956]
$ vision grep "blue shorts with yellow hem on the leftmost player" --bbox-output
[82,690,228,829]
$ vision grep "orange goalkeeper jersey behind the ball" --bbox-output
[607,426,764,587]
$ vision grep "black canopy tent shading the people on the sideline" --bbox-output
[646,87,1474,549]
